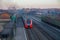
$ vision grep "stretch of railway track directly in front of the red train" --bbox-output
[26,29,39,40]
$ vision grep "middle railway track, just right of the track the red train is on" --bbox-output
[34,24,54,40]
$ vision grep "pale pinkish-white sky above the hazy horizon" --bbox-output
[0,0,60,9]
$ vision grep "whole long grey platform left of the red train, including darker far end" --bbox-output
[14,19,27,40]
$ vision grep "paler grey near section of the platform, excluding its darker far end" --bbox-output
[14,27,27,40]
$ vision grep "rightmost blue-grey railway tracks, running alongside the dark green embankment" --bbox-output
[33,16,60,40]
